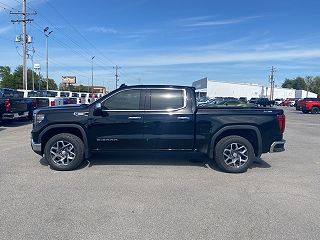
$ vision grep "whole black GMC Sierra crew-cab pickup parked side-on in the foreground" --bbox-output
[31,85,285,173]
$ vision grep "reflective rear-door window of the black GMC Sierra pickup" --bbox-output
[150,89,184,110]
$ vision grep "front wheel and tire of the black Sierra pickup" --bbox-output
[44,133,84,171]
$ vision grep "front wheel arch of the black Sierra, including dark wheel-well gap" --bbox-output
[39,124,90,158]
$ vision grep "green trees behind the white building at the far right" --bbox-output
[282,76,320,96]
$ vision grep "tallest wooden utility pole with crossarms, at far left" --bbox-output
[10,0,36,90]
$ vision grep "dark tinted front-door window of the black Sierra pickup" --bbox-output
[103,89,141,110]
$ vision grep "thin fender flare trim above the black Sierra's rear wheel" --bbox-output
[208,125,262,157]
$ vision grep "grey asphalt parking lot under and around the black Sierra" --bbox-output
[0,108,320,240]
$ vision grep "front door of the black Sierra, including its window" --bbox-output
[89,89,145,151]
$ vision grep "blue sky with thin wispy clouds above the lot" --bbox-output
[0,0,320,89]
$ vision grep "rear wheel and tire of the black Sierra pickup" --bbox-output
[214,135,255,173]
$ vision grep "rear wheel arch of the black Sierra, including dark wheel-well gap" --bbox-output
[208,125,262,157]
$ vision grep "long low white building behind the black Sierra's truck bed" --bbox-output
[192,78,317,99]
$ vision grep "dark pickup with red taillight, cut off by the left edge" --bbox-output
[0,88,29,122]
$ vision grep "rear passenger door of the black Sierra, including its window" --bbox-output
[144,88,195,150]
